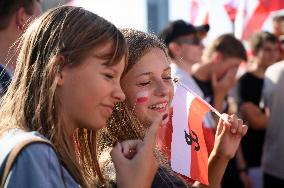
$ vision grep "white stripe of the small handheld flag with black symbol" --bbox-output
[171,86,195,177]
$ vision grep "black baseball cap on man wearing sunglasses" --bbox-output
[159,20,209,45]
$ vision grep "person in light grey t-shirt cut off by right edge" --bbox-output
[260,61,284,188]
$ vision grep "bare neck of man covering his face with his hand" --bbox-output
[192,62,212,81]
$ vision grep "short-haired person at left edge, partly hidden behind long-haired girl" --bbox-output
[0,0,42,97]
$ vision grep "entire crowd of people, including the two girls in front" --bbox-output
[0,0,284,188]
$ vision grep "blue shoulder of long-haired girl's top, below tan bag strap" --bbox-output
[2,133,73,188]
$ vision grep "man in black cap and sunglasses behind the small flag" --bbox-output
[159,20,216,164]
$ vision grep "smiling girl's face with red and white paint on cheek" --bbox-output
[121,48,173,125]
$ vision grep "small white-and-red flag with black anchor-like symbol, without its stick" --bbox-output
[171,85,209,185]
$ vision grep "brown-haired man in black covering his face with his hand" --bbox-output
[192,34,247,187]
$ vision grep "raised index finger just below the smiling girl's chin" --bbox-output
[144,116,162,149]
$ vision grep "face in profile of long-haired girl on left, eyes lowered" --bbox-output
[56,44,125,130]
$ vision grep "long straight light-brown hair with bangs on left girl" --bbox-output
[0,6,128,187]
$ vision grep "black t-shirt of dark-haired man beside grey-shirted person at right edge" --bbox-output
[238,73,265,167]
